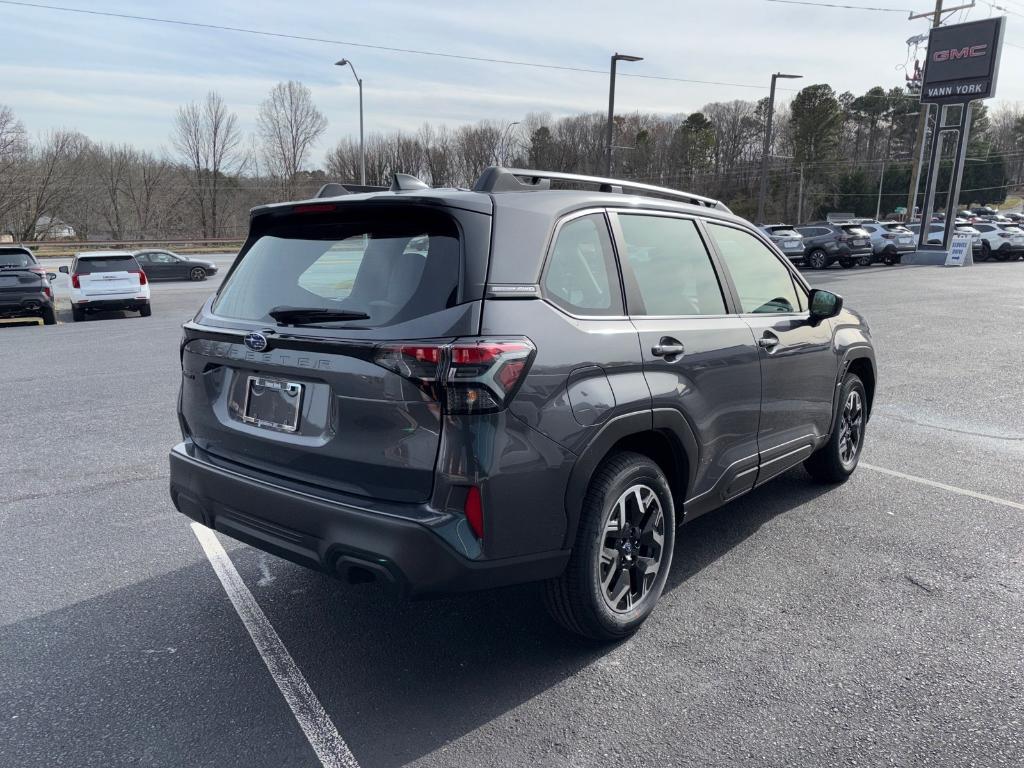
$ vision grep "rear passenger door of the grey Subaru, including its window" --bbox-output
[613,211,761,517]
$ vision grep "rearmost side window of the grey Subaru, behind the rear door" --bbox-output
[544,213,623,314]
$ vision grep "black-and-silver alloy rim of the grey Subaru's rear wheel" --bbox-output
[597,484,665,613]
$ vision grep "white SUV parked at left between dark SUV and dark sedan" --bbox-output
[60,251,152,323]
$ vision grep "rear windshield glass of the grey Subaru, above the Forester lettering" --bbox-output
[213,209,461,328]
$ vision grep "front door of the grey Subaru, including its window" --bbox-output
[707,221,839,483]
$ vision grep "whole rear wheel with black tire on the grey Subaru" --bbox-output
[544,452,676,641]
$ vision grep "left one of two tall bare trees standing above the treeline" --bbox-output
[171,91,244,238]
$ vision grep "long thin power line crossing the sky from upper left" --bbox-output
[0,0,774,90]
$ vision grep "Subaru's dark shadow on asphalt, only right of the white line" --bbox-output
[220,462,827,767]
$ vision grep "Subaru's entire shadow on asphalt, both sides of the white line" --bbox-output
[0,472,827,768]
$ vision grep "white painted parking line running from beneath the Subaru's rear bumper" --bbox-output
[191,522,359,768]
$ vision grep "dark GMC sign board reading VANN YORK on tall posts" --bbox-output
[921,17,1005,104]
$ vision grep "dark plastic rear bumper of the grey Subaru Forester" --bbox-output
[170,443,569,597]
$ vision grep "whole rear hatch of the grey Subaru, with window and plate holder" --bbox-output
[181,203,490,502]
